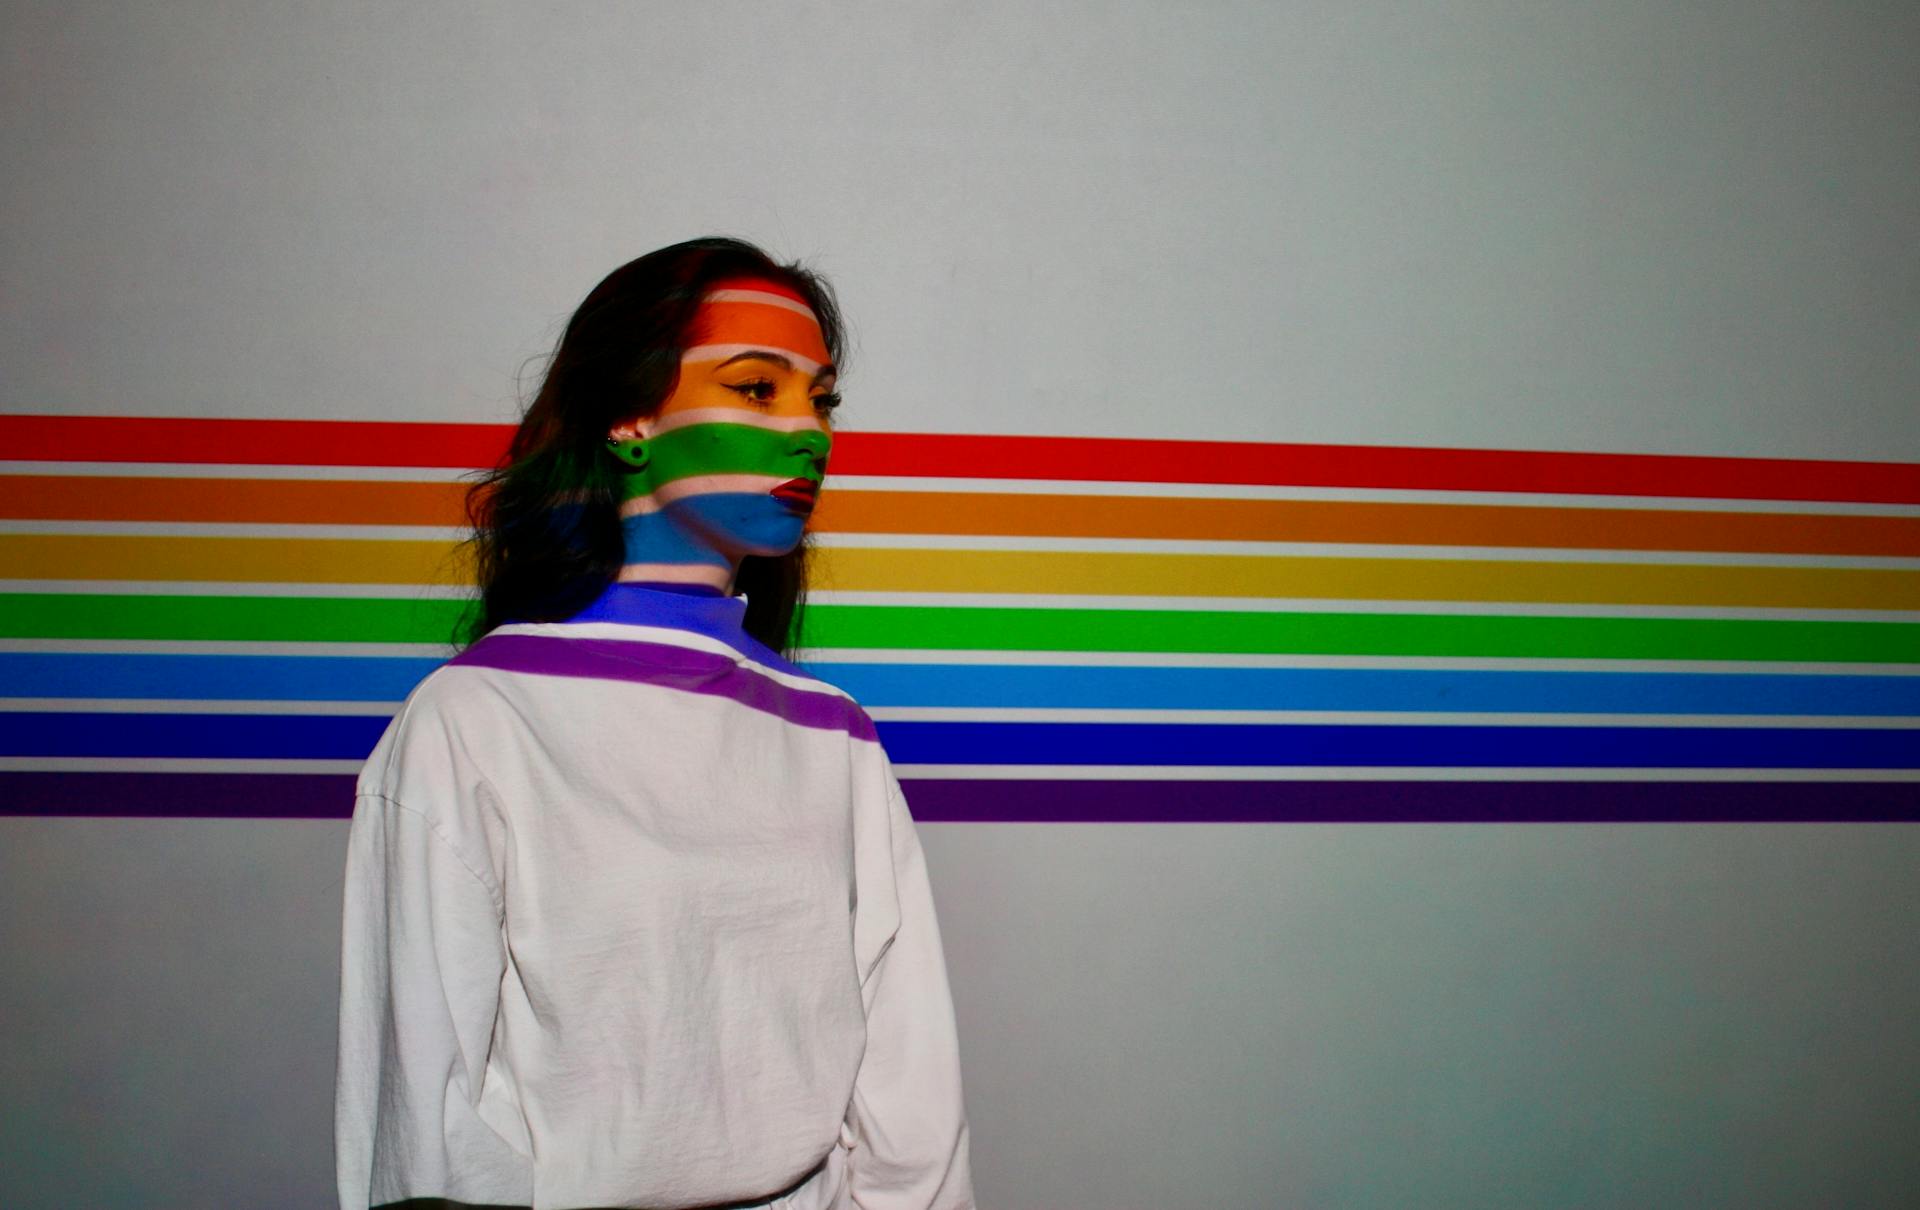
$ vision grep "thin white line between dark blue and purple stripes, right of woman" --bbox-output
[893,764,1920,784]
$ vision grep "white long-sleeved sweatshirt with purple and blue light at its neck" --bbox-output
[334,584,973,1210]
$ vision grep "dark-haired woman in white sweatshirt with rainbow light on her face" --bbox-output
[334,238,973,1210]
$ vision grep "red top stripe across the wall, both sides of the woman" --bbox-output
[0,415,1920,503]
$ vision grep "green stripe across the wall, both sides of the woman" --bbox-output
[0,593,1920,665]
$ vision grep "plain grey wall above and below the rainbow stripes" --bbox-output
[0,2,1920,1208]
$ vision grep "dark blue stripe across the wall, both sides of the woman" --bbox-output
[0,713,1920,768]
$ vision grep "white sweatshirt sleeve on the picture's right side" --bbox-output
[843,766,973,1210]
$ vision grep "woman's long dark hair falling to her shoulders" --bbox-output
[455,236,845,655]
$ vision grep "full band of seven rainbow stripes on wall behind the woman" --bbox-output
[0,415,1920,822]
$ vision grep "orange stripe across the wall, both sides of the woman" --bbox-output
[0,474,1920,557]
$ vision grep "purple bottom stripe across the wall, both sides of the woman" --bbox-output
[0,772,1920,824]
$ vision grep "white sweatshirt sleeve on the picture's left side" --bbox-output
[334,793,532,1210]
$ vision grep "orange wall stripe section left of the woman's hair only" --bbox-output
[0,474,467,526]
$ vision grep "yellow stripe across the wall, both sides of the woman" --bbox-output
[0,534,1920,609]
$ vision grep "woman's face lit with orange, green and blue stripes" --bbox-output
[609,278,839,570]
